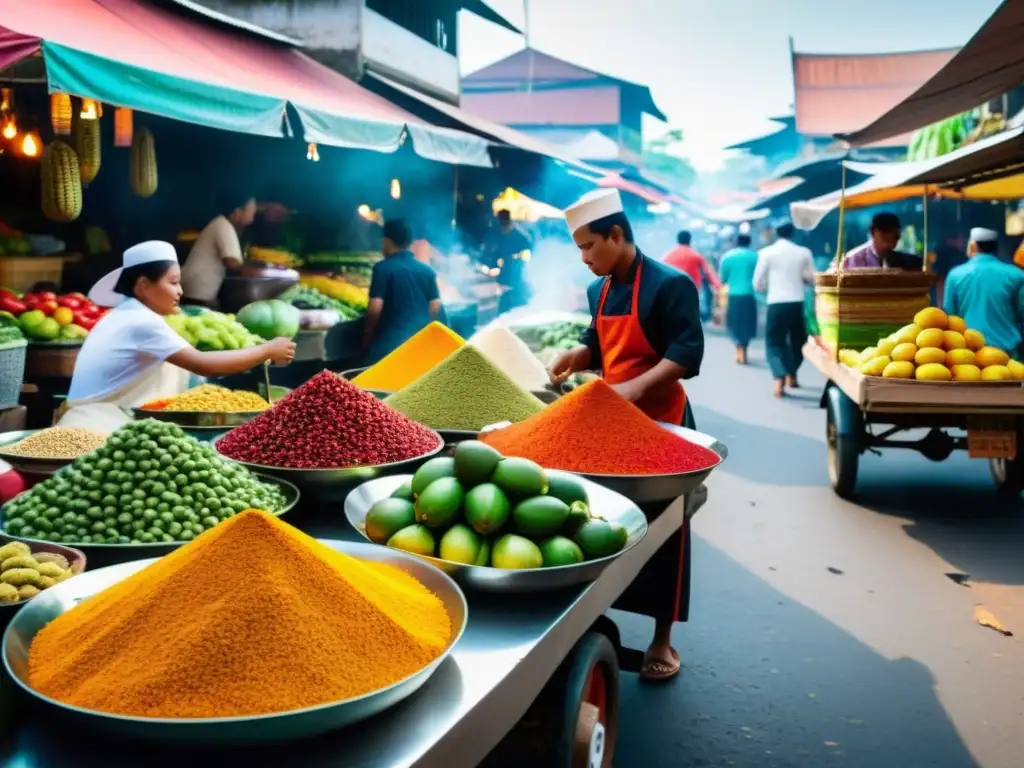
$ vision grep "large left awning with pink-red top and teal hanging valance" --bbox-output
[0,0,492,167]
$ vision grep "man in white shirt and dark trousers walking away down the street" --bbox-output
[754,222,814,397]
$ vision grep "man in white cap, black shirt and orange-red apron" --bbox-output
[550,189,703,680]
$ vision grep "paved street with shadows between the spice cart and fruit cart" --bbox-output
[615,336,1024,768]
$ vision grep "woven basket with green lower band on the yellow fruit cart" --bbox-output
[814,269,937,352]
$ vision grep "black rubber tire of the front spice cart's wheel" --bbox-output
[552,632,618,768]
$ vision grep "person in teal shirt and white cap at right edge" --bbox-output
[944,227,1024,357]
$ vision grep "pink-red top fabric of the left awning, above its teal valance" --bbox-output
[0,0,424,125]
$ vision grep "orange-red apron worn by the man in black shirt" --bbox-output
[595,260,686,424]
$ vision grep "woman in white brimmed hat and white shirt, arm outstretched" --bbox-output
[66,241,295,413]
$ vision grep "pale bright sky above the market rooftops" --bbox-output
[459,0,999,171]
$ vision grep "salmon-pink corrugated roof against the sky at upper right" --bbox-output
[793,48,957,146]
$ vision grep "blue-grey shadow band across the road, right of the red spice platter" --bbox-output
[693,403,828,486]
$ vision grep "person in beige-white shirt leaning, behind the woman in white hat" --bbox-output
[181,198,256,307]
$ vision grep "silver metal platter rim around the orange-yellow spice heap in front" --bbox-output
[3,540,469,745]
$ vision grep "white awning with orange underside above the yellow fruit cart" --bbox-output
[790,128,1024,229]
